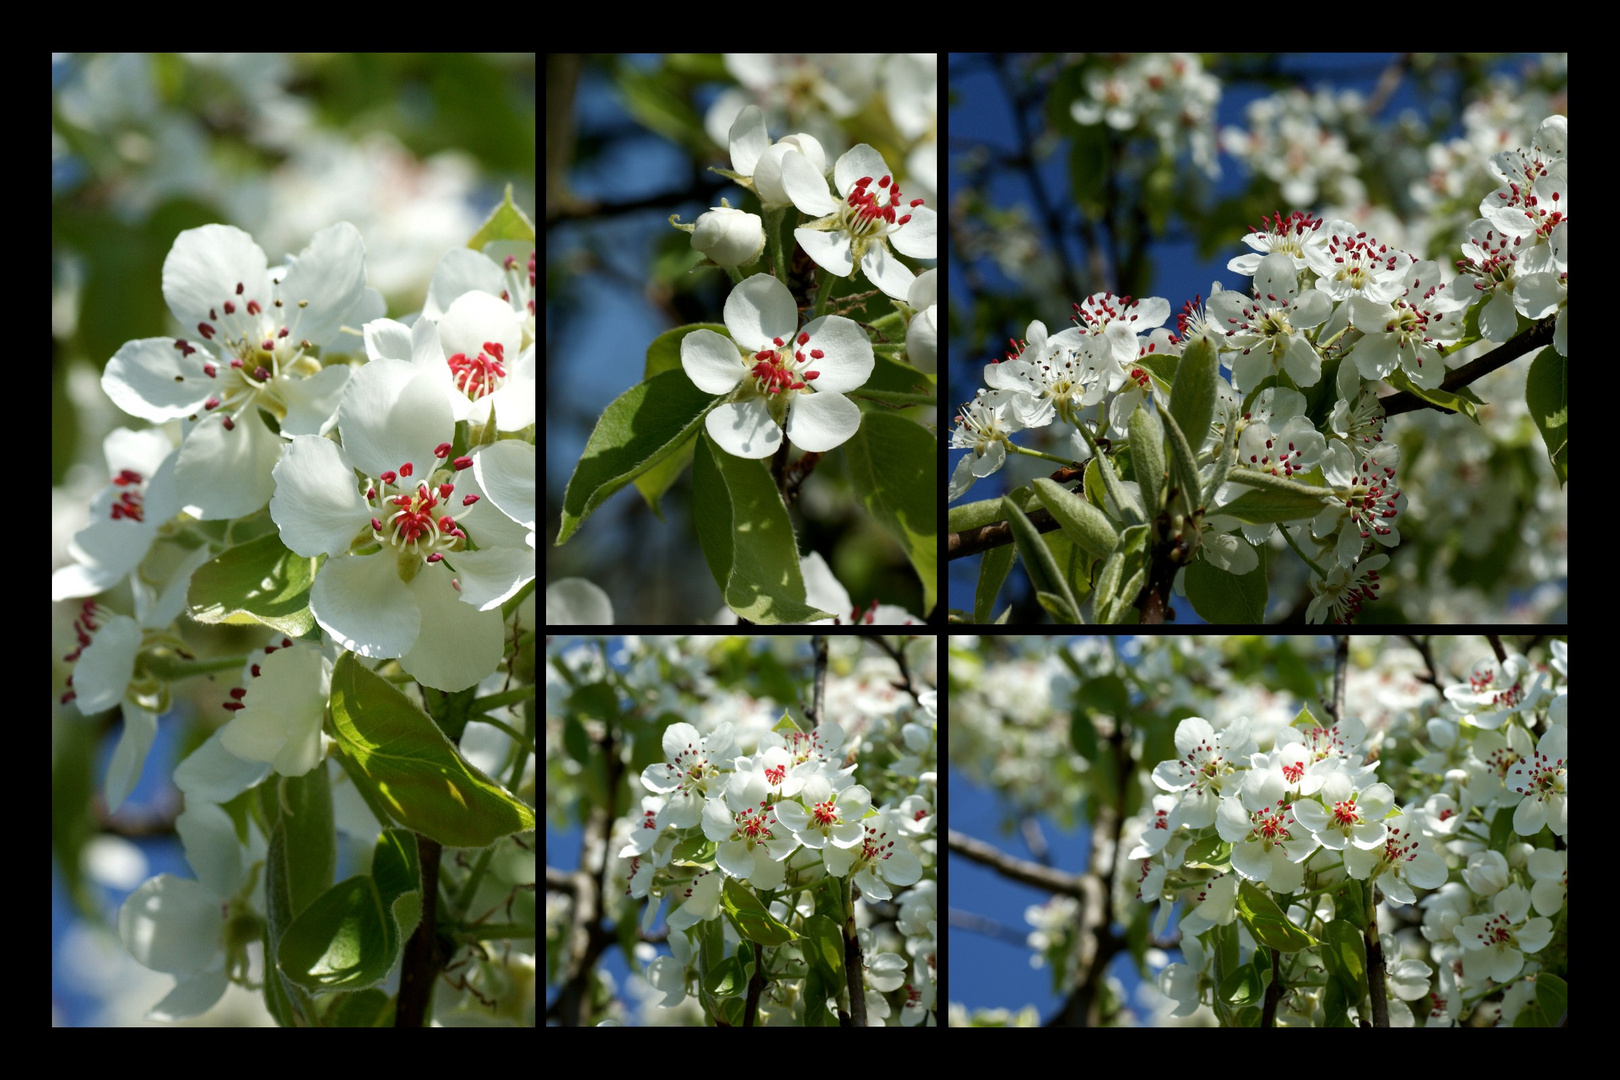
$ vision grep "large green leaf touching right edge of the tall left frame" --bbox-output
[332,653,535,847]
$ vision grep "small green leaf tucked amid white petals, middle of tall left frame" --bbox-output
[186,533,316,638]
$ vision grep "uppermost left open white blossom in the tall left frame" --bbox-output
[102,222,370,520]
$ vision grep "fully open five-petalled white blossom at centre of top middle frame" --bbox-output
[680,274,873,458]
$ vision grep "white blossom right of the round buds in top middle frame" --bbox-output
[792,142,938,300]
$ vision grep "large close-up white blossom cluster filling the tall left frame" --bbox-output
[52,222,535,1018]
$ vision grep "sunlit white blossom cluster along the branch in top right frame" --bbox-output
[949,117,1568,622]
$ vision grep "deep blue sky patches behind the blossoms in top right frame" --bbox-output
[946,53,1542,623]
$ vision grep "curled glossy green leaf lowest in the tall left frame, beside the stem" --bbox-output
[275,829,421,991]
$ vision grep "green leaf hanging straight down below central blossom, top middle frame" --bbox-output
[692,431,833,623]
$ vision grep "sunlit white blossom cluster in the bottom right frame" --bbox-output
[1126,641,1568,1023]
